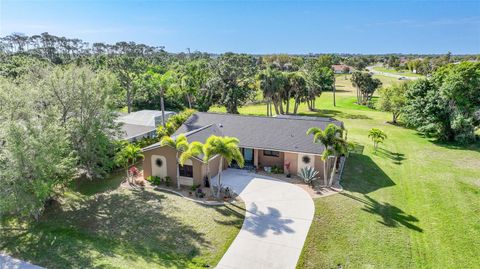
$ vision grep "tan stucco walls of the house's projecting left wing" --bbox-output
[143,146,206,186]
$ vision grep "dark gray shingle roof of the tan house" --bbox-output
[174,112,343,154]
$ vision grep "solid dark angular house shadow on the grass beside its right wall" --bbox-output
[341,153,395,194]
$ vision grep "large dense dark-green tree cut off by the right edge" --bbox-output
[404,62,480,143]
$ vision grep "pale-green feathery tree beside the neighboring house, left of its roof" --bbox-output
[44,65,118,178]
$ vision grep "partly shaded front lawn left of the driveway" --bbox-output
[0,173,244,268]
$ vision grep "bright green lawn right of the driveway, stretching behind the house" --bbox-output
[214,78,480,268]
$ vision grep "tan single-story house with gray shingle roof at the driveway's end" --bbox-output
[143,112,343,185]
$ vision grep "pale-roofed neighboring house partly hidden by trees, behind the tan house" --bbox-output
[116,110,176,142]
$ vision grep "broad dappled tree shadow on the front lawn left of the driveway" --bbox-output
[1,188,210,268]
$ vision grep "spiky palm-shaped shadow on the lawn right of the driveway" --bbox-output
[341,193,423,232]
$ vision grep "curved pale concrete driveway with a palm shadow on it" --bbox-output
[212,169,315,269]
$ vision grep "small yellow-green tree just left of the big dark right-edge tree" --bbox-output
[378,83,408,124]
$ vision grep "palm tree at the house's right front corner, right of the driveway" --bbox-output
[307,123,342,186]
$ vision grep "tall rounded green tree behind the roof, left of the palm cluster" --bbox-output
[213,53,255,114]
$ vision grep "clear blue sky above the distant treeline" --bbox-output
[0,0,480,54]
